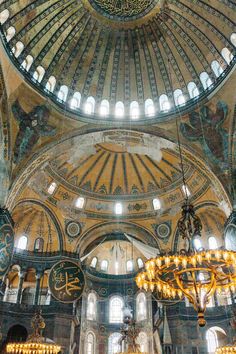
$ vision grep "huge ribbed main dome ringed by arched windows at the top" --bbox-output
[0,0,235,122]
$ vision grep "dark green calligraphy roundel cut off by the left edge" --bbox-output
[0,209,14,279]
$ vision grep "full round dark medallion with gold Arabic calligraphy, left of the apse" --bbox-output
[48,260,85,303]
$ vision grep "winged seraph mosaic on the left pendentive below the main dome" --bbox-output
[12,100,56,163]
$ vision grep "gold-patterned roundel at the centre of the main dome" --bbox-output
[94,0,155,17]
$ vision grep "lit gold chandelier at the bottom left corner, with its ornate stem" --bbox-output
[6,312,61,354]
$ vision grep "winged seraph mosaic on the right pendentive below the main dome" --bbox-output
[180,101,228,169]
